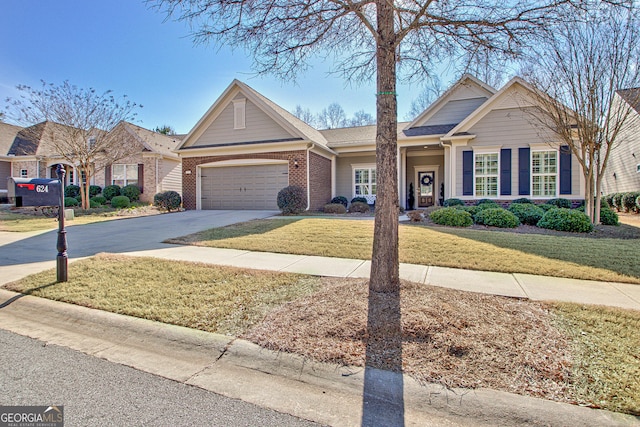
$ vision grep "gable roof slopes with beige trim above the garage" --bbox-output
[176,79,327,150]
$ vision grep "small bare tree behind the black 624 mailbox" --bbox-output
[6,81,141,209]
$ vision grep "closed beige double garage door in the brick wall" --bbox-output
[200,164,289,209]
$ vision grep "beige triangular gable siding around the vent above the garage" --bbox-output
[192,100,292,147]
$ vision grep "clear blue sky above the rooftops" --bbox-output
[0,0,440,133]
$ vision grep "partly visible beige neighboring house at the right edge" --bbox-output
[602,88,640,194]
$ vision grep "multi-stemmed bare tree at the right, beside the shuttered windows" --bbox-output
[526,1,640,224]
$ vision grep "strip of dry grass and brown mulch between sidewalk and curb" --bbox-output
[7,254,640,415]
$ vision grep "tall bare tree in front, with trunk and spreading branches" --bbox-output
[149,0,570,292]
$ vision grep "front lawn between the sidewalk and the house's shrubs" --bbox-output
[168,218,640,284]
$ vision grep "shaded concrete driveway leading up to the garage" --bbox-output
[0,210,279,284]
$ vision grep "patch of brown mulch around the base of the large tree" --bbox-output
[244,279,572,401]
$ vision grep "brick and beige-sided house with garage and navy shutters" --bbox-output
[177,75,584,210]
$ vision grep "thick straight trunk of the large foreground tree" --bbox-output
[369,0,400,292]
